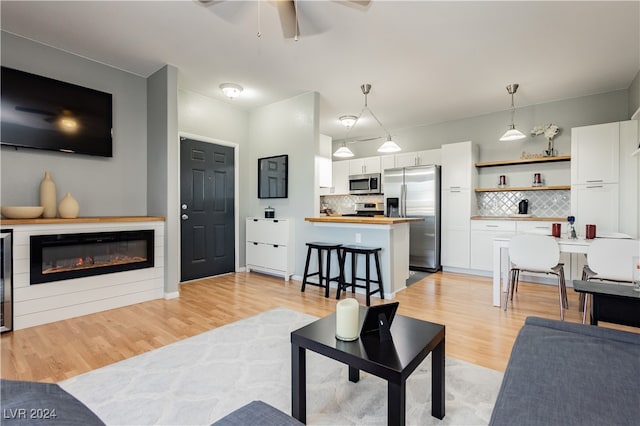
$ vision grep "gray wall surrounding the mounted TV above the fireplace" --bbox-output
[0,32,147,216]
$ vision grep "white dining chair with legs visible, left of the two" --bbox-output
[504,234,569,320]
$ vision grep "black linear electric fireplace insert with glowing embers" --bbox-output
[30,230,154,284]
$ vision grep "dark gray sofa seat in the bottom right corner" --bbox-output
[489,317,640,426]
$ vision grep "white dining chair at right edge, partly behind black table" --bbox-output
[580,238,640,324]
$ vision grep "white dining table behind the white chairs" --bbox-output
[493,235,592,306]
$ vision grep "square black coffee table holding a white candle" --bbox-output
[291,306,445,425]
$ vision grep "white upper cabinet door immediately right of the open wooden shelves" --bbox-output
[571,123,620,185]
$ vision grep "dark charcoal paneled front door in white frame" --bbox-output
[180,137,236,281]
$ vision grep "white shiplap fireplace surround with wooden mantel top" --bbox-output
[2,217,165,330]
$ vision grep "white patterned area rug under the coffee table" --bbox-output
[60,308,502,425]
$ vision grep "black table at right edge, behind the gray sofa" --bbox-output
[573,280,640,327]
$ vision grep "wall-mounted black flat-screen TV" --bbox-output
[0,67,113,157]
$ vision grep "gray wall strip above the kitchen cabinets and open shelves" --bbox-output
[333,90,633,161]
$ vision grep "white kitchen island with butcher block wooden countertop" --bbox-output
[305,216,423,299]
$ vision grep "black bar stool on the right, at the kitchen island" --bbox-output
[336,246,384,306]
